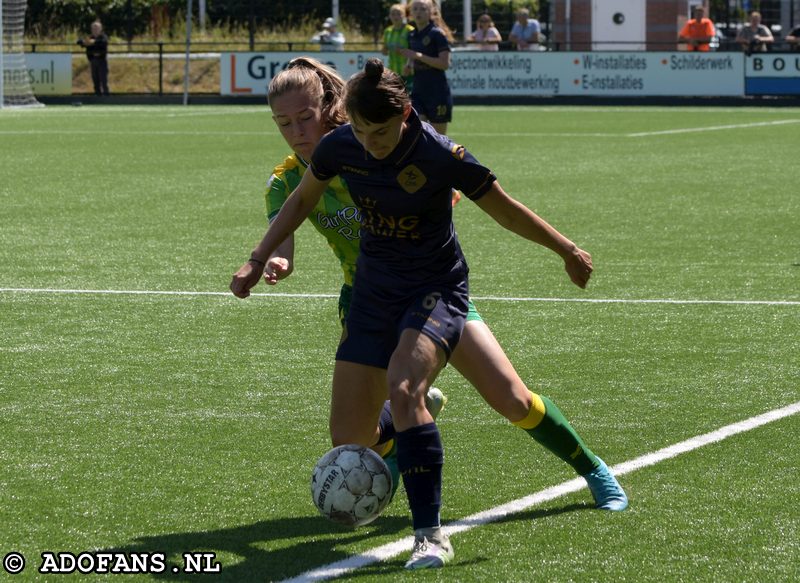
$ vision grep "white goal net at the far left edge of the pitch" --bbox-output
[0,0,42,108]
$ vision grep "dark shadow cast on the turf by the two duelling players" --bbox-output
[106,504,592,582]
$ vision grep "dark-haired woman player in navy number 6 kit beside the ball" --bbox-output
[231,59,627,568]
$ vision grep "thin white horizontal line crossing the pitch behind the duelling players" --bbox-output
[0,287,800,306]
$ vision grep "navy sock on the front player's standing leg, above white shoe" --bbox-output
[396,423,444,530]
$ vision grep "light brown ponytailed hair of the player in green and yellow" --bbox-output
[267,57,347,129]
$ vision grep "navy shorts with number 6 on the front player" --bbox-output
[336,280,469,369]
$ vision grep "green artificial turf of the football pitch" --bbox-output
[0,106,800,582]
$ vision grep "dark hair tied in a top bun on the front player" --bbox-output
[344,57,411,123]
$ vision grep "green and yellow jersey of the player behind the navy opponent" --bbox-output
[264,154,361,285]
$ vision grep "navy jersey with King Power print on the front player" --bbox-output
[310,110,495,291]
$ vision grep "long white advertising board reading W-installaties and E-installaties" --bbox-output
[220,51,744,97]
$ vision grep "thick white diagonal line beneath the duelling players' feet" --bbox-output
[283,401,800,583]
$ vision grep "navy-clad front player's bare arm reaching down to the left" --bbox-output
[230,172,330,298]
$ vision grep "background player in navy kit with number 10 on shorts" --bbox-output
[399,0,453,134]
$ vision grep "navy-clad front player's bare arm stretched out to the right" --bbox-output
[475,181,592,288]
